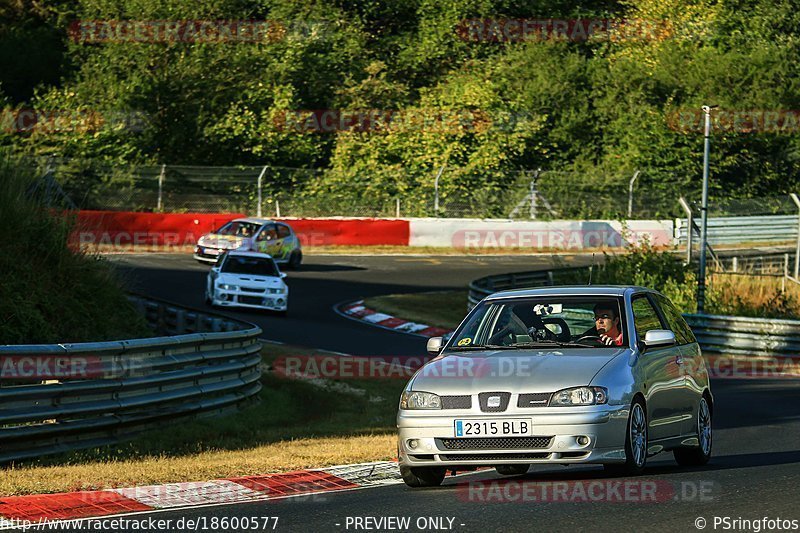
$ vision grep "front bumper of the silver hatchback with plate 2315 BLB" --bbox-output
[397,405,629,467]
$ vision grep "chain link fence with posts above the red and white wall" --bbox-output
[36,159,744,220]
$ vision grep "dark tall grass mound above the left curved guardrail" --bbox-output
[0,152,149,344]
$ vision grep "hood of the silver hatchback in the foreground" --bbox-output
[412,348,629,395]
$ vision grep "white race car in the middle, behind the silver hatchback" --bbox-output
[205,250,289,316]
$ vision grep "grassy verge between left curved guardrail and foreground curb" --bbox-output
[0,345,405,496]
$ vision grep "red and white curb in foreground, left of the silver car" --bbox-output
[0,461,403,529]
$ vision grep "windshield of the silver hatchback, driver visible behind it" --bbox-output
[448,296,626,351]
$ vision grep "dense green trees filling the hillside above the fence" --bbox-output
[0,0,800,209]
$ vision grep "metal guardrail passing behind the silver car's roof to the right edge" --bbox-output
[468,267,800,358]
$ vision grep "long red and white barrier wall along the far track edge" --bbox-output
[73,211,674,250]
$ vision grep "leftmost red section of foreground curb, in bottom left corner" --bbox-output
[0,491,152,521]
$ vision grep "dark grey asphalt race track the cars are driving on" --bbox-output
[104,255,800,533]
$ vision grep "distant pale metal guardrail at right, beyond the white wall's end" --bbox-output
[675,215,797,246]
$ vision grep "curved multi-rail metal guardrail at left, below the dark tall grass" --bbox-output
[0,296,261,462]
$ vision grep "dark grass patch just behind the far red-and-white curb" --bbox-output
[364,290,468,329]
